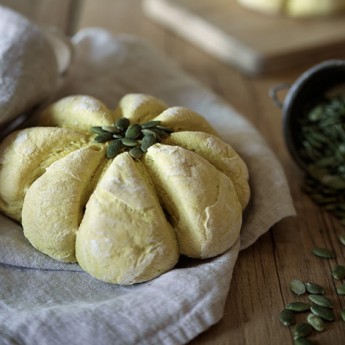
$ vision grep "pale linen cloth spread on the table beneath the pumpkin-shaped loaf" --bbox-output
[0,6,295,345]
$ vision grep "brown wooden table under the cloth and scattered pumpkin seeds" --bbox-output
[5,0,345,345]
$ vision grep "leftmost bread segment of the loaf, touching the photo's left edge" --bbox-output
[0,127,87,222]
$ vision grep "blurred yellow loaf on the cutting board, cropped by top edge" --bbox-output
[237,0,345,17]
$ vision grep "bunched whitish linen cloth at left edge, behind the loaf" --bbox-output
[0,6,58,126]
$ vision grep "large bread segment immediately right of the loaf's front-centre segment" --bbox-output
[144,144,242,258]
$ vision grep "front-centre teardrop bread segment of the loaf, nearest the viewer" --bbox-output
[76,152,179,285]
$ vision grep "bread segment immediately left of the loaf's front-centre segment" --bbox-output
[22,145,106,262]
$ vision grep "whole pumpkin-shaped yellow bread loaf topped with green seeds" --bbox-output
[0,94,250,285]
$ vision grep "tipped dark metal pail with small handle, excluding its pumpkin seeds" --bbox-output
[270,60,345,170]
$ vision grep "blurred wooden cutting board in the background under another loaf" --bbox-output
[143,0,345,74]
